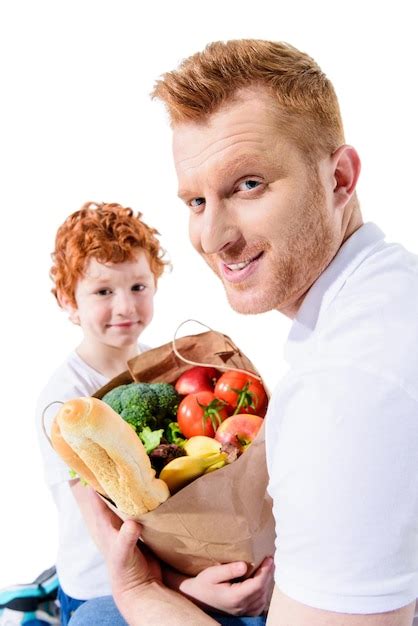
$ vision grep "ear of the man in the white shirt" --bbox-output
[331,145,361,208]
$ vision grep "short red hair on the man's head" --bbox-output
[152,39,344,162]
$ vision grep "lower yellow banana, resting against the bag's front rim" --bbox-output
[159,452,227,495]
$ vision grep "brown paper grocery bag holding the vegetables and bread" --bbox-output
[95,331,275,576]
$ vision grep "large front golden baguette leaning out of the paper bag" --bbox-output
[52,398,170,517]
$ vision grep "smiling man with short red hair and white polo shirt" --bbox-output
[74,40,418,626]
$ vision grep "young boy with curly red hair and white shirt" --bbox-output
[37,203,271,626]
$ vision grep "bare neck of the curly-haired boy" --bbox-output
[76,339,139,378]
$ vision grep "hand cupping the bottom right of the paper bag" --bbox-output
[164,557,274,616]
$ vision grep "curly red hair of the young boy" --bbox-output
[50,202,168,306]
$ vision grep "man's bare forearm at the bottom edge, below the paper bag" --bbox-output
[115,581,218,626]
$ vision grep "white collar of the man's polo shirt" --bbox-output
[288,222,385,341]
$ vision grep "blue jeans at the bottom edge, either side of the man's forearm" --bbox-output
[69,596,266,626]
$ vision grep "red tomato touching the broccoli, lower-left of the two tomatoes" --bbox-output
[177,391,228,439]
